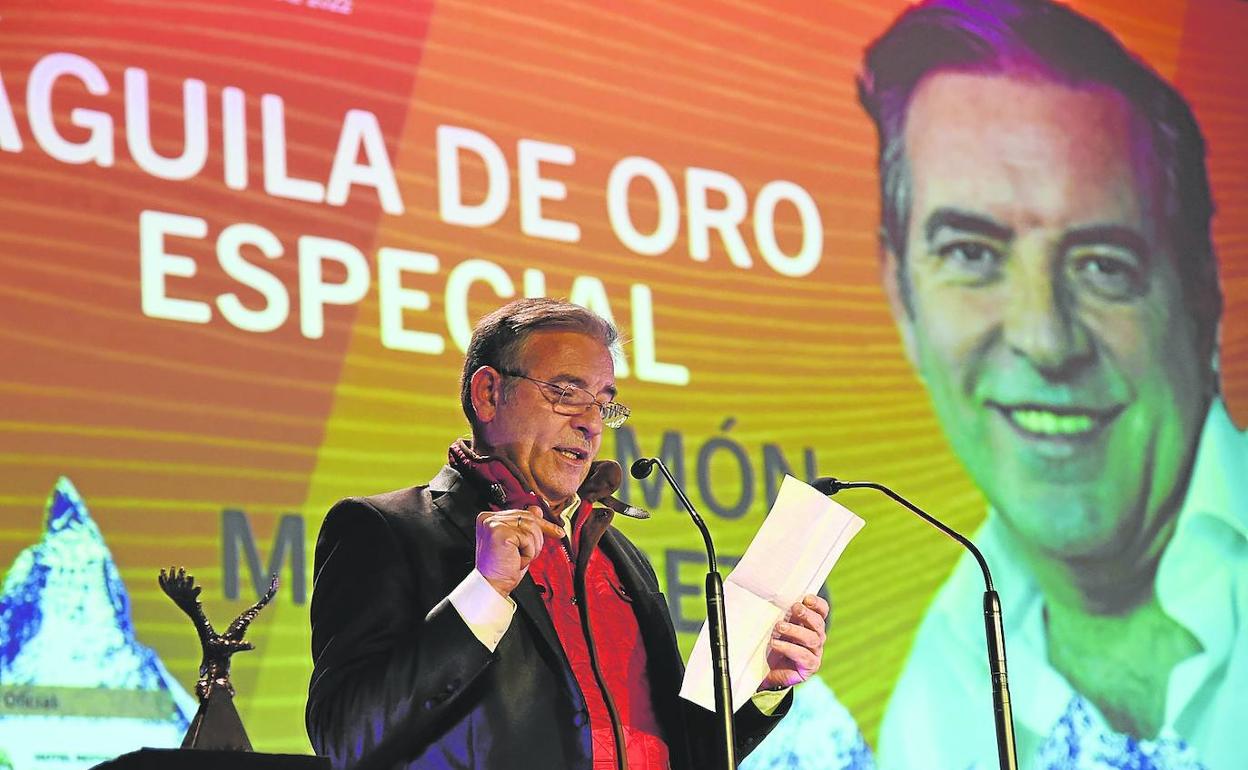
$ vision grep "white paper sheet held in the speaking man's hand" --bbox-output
[680,475,865,711]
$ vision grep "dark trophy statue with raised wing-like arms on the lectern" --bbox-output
[158,567,277,751]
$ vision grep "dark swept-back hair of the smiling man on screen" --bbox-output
[859,0,1222,359]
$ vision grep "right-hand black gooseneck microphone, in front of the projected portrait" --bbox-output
[811,477,1018,770]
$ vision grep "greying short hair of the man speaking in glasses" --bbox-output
[459,297,619,431]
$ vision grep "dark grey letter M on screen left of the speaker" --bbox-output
[221,508,308,604]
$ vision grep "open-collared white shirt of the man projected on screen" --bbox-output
[877,401,1248,770]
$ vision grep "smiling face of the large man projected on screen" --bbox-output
[886,72,1212,558]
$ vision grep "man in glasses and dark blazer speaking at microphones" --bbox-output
[307,300,827,770]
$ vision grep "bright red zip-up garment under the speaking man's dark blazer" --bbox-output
[529,502,669,770]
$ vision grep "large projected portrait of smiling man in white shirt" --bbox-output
[860,0,1248,770]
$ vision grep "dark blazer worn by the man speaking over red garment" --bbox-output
[307,468,791,770]
